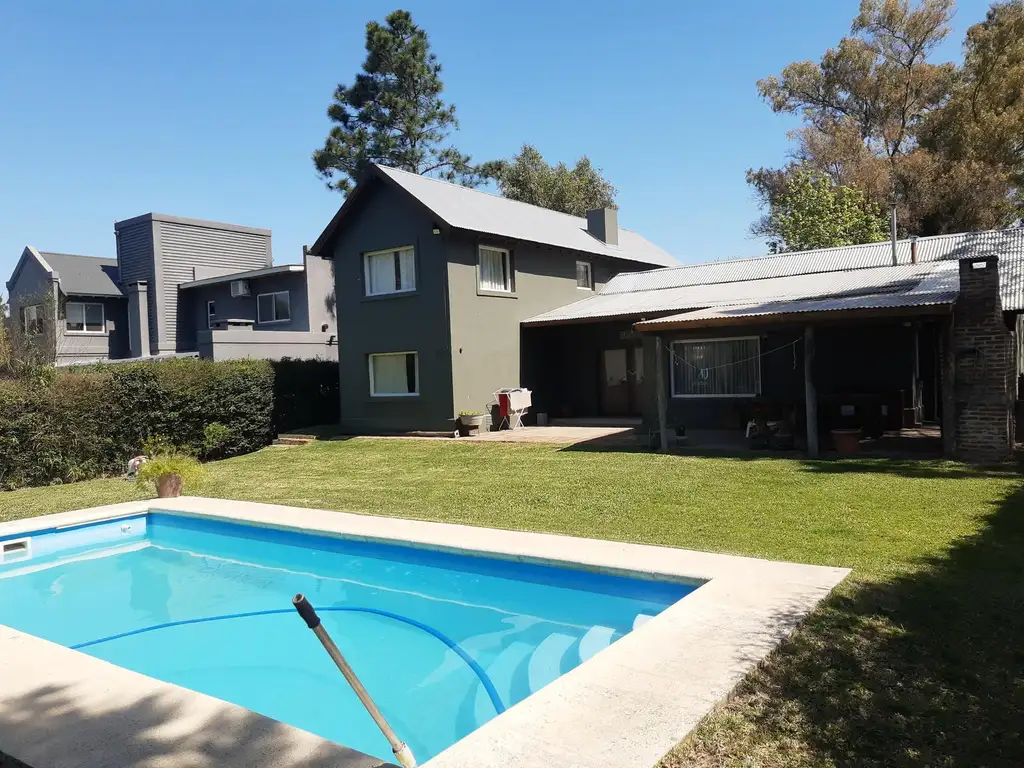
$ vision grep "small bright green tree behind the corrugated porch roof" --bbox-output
[761,168,886,253]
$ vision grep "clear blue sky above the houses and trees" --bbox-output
[0,0,988,289]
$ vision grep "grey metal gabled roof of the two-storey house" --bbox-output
[310,165,679,266]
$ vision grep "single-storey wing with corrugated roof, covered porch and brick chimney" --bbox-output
[522,228,1024,460]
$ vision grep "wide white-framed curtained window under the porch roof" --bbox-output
[671,336,761,397]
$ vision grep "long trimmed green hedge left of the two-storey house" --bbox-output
[0,358,339,489]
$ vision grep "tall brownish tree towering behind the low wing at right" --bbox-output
[748,0,1022,240]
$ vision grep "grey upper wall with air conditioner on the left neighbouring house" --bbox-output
[178,272,309,351]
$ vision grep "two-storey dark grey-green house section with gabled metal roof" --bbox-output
[310,166,677,432]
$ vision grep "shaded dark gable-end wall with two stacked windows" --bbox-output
[333,181,454,433]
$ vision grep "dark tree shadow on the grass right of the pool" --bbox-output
[667,487,1024,768]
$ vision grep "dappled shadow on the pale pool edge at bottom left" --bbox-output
[0,681,390,768]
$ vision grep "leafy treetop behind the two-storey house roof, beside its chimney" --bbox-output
[478,144,615,216]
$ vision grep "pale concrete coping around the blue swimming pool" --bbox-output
[0,497,850,768]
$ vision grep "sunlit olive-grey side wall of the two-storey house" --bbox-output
[445,236,626,413]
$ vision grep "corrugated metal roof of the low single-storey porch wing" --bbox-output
[524,228,1024,325]
